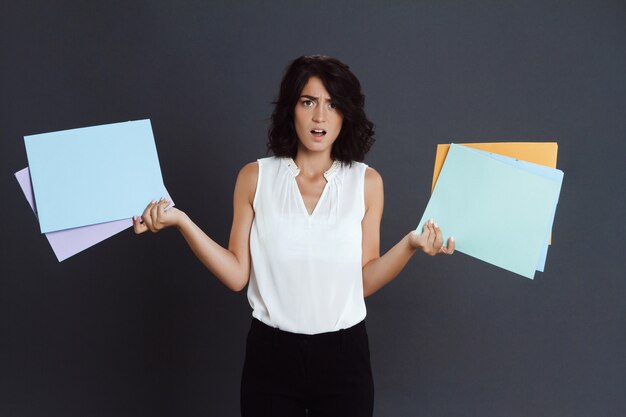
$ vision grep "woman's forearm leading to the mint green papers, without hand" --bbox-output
[363,234,416,297]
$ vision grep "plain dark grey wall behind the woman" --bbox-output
[0,0,626,417]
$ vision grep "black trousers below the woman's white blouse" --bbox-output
[241,319,374,417]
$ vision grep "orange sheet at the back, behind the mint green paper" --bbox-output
[431,142,559,244]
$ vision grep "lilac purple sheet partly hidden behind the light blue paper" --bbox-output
[15,167,174,262]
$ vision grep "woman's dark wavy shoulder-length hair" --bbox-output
[267,55,374,164]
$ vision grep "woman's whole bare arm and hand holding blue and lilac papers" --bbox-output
[133,162,258,291]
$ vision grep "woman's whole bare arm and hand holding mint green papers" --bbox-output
[361,168,454,297]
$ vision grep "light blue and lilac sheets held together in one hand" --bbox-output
[15,120,169,261]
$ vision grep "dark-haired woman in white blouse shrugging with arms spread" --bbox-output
[134,56,454,417]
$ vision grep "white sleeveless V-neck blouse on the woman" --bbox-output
[248,157,367,334]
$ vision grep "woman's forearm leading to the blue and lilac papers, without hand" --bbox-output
[177,213,250,291]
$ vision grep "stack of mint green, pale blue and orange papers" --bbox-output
[417,144,563,278]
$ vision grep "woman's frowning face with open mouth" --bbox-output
[294,77,343,154]
